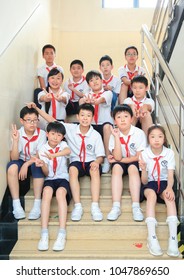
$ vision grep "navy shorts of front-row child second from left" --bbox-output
[43,179,72,205]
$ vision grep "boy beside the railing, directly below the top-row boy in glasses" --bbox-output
[123,75,155,134]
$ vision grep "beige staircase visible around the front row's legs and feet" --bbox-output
[9,174,181,260]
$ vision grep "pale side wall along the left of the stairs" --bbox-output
[0,0,52,204]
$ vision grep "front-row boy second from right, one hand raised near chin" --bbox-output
[107,105,146,221]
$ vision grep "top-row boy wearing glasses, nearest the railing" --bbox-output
[118,46,145,104]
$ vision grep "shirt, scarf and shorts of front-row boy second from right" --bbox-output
[109,125,147,174]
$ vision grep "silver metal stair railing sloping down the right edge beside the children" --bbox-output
[141,25,184,220]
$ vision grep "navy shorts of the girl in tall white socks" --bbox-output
[140,181,167,203]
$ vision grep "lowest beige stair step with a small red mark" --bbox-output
[10,238,181,260]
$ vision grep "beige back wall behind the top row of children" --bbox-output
[52,0,153,78]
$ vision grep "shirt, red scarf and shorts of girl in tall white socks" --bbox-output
[141,146,175,202]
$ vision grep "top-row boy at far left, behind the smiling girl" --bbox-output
[34,44,64,107]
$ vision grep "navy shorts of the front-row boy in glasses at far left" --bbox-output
[7,159,45,178]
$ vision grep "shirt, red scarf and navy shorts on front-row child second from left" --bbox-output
[39,141,71,204]
